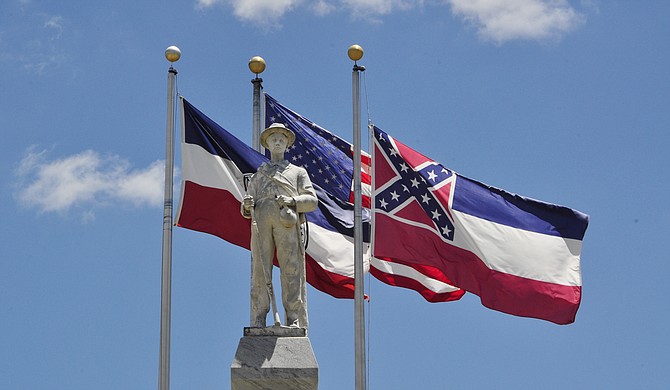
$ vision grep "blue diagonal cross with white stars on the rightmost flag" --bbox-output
[375,129,456,241]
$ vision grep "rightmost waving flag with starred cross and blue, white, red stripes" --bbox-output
[373,128,588,324]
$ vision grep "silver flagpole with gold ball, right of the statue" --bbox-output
[347,45,367,390]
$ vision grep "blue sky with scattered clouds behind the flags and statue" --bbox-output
[0,0,670,389]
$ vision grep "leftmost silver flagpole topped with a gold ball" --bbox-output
[158,46,181,390]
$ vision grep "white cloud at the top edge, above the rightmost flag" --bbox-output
[447,0,585,43]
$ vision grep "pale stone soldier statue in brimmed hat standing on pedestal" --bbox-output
[241,123,317,328]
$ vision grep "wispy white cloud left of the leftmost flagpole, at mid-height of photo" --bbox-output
[15,148,165,221]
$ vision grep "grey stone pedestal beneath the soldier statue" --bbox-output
[230,326,319,390]
